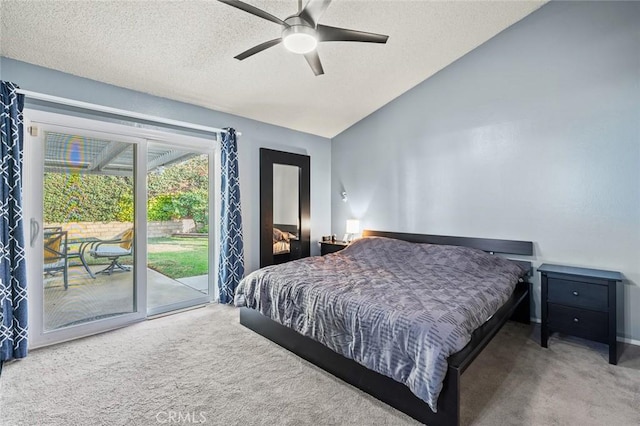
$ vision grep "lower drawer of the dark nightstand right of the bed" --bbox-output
[547,303,609,343]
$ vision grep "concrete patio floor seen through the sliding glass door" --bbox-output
[44,265,208,330]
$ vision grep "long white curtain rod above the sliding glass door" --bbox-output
[16,89,242,136]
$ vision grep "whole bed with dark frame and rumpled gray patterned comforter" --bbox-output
[236,231,532,425]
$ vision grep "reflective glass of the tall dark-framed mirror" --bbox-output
[273,164,301,264]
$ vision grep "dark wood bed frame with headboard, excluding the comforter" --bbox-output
[240,230,533,426]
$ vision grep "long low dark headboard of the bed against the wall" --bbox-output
[362,229,533,273]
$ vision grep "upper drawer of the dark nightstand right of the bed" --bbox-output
[547,278,609,312]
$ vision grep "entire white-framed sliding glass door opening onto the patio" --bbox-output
[24,111,213,347]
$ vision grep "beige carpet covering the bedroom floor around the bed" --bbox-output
[0,305,640,426]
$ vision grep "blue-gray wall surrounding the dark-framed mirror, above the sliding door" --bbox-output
[0,58,331,272]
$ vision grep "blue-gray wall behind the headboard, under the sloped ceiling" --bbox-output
[331,2,640,339]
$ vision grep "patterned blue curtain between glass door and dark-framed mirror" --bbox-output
[218,129,244,303]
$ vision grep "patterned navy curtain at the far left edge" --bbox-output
[0,81,27,368]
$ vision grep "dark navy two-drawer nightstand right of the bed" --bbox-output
[538,263,622,364]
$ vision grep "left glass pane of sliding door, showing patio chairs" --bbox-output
[42,128,136,331]
